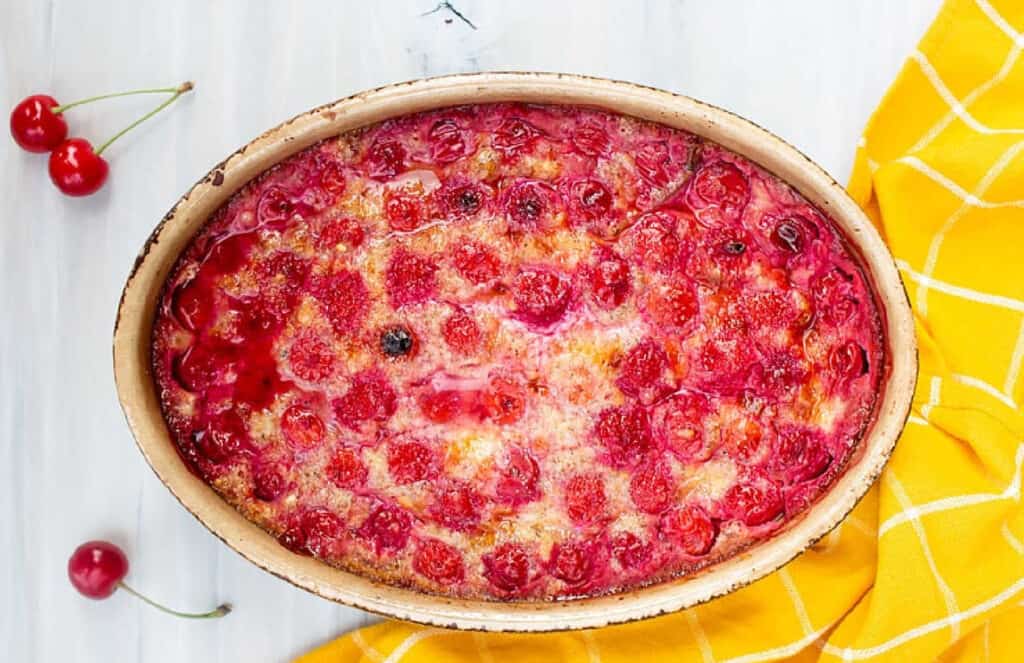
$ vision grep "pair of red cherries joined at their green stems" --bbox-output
[10,82,193,196]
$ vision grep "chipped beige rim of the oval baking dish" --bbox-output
[114,73,918,631]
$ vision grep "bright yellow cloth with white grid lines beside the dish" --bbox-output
[300,0,1024,663]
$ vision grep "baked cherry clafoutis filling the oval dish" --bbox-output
[153,103,888,600]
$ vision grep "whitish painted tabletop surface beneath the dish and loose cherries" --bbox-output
[0,0,938,661]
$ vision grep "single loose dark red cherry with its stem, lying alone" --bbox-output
[68,541,231,619]
